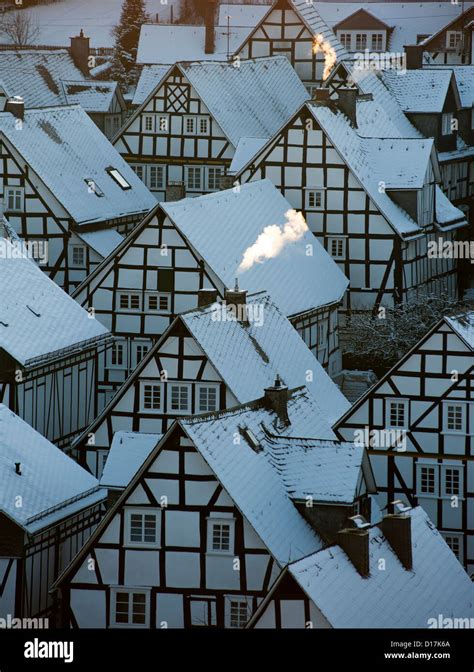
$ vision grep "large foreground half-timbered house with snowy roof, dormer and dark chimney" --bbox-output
[55,385,373,629]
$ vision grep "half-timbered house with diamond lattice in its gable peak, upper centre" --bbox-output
[114,56,308,201]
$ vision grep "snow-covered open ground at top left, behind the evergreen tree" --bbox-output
[1,0,185,47]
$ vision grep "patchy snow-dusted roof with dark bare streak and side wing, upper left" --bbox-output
[0,49,117,112]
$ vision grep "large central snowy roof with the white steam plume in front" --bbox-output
[161,180,348,316]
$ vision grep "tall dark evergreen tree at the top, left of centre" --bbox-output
[112,0,149,87]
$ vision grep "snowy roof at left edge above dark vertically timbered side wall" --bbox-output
[0,239,109,366]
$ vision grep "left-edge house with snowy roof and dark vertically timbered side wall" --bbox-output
[0,238,110,447]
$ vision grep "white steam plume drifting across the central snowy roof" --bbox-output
[237,210,309,274]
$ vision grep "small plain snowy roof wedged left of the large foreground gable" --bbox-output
[100,431,162,488]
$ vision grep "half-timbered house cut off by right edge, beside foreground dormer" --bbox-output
[335,311,474,575]
